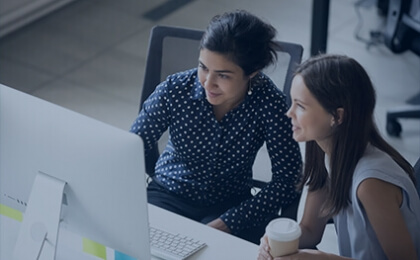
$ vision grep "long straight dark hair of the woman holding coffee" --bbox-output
[295,54,415,216]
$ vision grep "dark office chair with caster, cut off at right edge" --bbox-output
[384,0,420,137]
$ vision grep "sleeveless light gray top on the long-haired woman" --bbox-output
[327,146,420,260]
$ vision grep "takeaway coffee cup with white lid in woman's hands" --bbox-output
[265,218,301,257]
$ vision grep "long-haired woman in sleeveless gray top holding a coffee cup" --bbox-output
[259,54,420,259]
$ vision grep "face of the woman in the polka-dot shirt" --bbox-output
[198,49,249,110]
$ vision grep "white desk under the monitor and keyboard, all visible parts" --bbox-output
[0,205,258,260]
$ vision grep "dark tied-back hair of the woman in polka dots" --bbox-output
[200,10,277,75]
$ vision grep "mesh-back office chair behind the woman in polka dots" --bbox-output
[139,25,303,242]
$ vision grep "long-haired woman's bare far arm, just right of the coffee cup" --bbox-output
[299,189,329,248]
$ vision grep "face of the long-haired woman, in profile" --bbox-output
[286,74,334,145]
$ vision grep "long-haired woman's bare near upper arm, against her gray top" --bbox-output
[357,178,417,259]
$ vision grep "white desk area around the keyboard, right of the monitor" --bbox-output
[149,204,258,260]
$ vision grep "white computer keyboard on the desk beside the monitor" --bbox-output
[150,227,206,260]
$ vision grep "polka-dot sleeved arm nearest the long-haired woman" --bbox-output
[220,89,302,233]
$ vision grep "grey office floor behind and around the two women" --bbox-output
[0,0,420,252]
